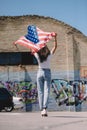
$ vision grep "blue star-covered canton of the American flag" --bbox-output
[25,25,39,44]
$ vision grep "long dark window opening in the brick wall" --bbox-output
[0,52,37,65]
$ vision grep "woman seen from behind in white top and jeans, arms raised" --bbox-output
[34,34,57,116]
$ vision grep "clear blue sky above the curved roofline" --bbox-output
[0,0,87,36]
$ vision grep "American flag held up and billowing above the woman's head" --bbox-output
[14,25,55,52]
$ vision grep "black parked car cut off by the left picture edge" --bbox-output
[0,87,14,112]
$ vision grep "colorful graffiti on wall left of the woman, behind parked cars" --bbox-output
[0,81,37,103]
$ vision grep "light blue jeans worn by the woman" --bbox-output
[37,69,51,110]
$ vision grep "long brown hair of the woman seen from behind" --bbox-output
[37,46,50,62]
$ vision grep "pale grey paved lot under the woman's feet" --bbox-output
[0,111,87,130]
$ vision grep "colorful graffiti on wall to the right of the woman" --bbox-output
[52,79,87,111]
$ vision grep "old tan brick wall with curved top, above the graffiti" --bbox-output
[0,16,87,80]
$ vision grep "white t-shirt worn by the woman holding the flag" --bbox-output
[34,53,52,69]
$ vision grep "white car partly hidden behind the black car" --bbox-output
[13,96,24,109]
